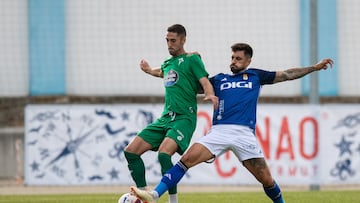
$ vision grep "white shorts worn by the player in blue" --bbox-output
[197,125,264,161]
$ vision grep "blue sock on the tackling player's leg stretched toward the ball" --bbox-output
[155,161,187,197]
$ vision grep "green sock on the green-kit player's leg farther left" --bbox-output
[124,151,147,188]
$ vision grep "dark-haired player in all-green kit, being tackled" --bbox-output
[124,24,218,203]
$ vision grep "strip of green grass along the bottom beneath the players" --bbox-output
[0,190,360,203]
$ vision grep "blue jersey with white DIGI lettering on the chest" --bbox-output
[210,68,276,129]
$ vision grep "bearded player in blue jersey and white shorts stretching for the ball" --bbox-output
[131,43,334,203]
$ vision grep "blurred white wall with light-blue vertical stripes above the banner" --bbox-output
[0,0,360,186]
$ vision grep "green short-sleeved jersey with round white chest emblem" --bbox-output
[161,54,209,115]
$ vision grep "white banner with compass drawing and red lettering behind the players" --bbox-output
[24,104,360,185]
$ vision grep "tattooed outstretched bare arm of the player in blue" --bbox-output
[274,58,334,83]
